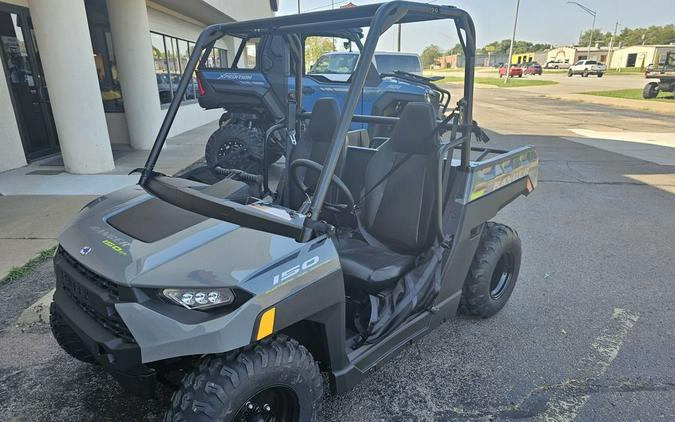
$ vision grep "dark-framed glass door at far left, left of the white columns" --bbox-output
[0,3,59,161]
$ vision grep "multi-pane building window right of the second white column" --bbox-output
[150,32,227,104]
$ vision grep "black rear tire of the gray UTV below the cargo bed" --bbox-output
[459,222,521,318]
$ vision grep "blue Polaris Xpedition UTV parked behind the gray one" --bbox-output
[197,29,450,178]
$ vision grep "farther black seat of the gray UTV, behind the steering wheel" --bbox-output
[288,97,347,210]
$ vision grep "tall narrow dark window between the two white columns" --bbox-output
[85,0,124,113]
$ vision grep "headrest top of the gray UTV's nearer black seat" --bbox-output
[387,102,438,154]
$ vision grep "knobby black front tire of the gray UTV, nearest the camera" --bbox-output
[164,335,323,422]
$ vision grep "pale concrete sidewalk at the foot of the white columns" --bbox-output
[0,122,217,280]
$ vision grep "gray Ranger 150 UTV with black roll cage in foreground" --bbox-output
[51,1,538,421]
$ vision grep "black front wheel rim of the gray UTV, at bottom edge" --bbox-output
[233,386,300,422]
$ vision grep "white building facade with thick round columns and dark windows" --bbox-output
[0,0,277,173]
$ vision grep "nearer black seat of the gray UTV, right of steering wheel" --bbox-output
[337,103,439,294]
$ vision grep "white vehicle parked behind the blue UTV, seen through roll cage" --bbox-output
[308,51,422,82]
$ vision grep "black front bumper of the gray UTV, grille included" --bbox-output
[52,249,156,397]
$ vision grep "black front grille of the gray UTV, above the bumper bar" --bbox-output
[54,247,136,343]
